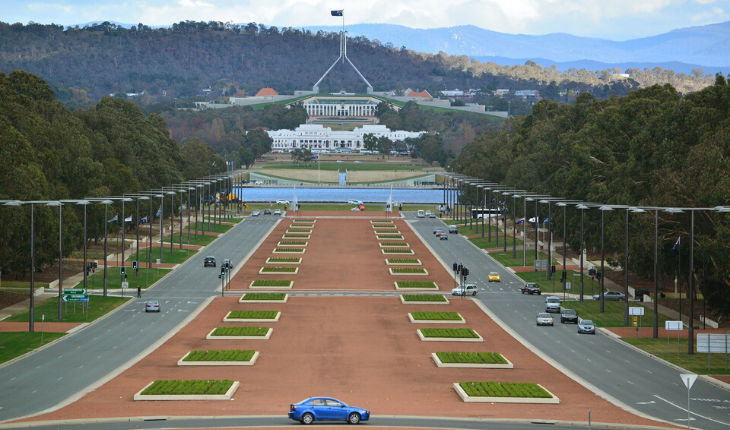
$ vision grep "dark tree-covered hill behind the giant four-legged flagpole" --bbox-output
[0,21,711,106]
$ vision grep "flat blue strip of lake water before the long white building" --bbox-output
[235,187,444,203]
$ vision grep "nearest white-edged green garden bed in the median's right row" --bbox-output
[454,382,560,405]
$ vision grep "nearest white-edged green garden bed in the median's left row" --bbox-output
[134,379,240,401]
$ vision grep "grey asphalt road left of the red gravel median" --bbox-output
[0,217,280,421]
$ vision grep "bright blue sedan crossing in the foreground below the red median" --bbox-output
[289,397,370,424]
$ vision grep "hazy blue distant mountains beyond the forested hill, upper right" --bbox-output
[304,21,730,74]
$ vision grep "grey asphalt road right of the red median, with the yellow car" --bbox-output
[407,214,730,430]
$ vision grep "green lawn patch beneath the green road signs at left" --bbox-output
[3,295,129,322]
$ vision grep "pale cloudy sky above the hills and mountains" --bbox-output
[5,0,730,40]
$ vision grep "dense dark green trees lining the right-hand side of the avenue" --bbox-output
[451,75,730,315]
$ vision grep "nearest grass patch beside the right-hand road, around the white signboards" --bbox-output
[622,338,730,375]
